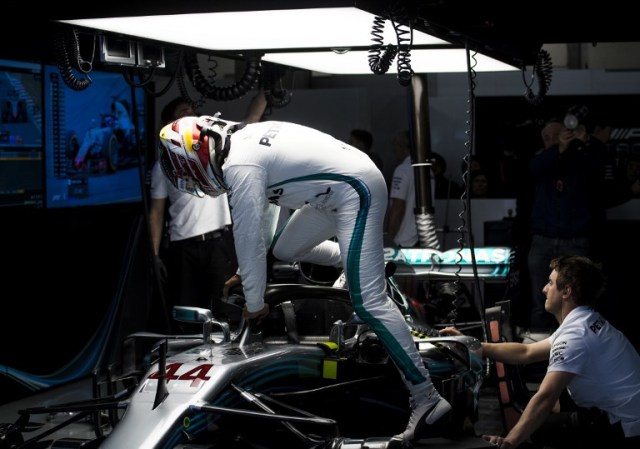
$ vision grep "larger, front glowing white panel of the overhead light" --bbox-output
[60,7,448,51]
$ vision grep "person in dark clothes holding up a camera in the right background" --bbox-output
[527,108,606,334]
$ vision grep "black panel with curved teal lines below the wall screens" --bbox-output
[0,203,164,403]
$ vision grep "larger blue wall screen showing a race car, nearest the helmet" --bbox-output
[44,65,146,208]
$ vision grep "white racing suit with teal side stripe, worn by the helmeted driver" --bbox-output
[222,121,432,394]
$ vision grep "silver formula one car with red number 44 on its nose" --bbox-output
[0,264,488,449]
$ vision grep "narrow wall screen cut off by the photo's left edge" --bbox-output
[0,60,44,207]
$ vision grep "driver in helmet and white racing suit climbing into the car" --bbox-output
[160,114,451,442]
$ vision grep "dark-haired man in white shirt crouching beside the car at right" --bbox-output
[440,256,640,449]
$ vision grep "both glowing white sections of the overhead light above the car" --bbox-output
[61,7,516,74]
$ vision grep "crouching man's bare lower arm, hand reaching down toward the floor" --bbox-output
[482,368,575,449]
